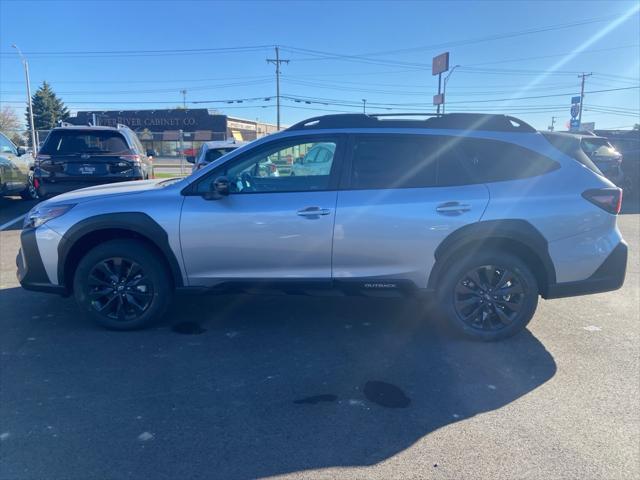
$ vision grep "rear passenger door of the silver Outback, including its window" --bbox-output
[333,134,489,289]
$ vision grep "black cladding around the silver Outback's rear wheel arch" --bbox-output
[428,220,556,294]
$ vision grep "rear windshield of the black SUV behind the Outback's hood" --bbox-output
[41,130,130,155]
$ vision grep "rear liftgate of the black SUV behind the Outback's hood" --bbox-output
[40,128,136,182]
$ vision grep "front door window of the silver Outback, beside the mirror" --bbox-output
[196,141,337,194]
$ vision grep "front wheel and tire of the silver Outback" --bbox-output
[73,240,173,330]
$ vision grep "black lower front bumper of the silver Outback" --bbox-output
[16,228,69,296]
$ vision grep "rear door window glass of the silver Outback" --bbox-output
[351,135,437,189]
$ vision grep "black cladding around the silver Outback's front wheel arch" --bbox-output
[58,212,184,287]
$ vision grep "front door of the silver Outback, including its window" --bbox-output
[180,136,341,286]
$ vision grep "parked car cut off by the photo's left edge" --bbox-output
[0,133,37,200]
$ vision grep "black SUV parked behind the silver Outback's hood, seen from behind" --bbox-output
[34,125,153,196]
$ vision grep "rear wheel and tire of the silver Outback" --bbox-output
[436,251,538,342]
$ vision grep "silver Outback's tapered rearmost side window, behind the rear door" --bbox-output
[438,137,560,186]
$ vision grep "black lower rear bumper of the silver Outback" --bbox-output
[545,241,627,298]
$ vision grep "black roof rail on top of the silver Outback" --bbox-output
[287,113,536,133]
